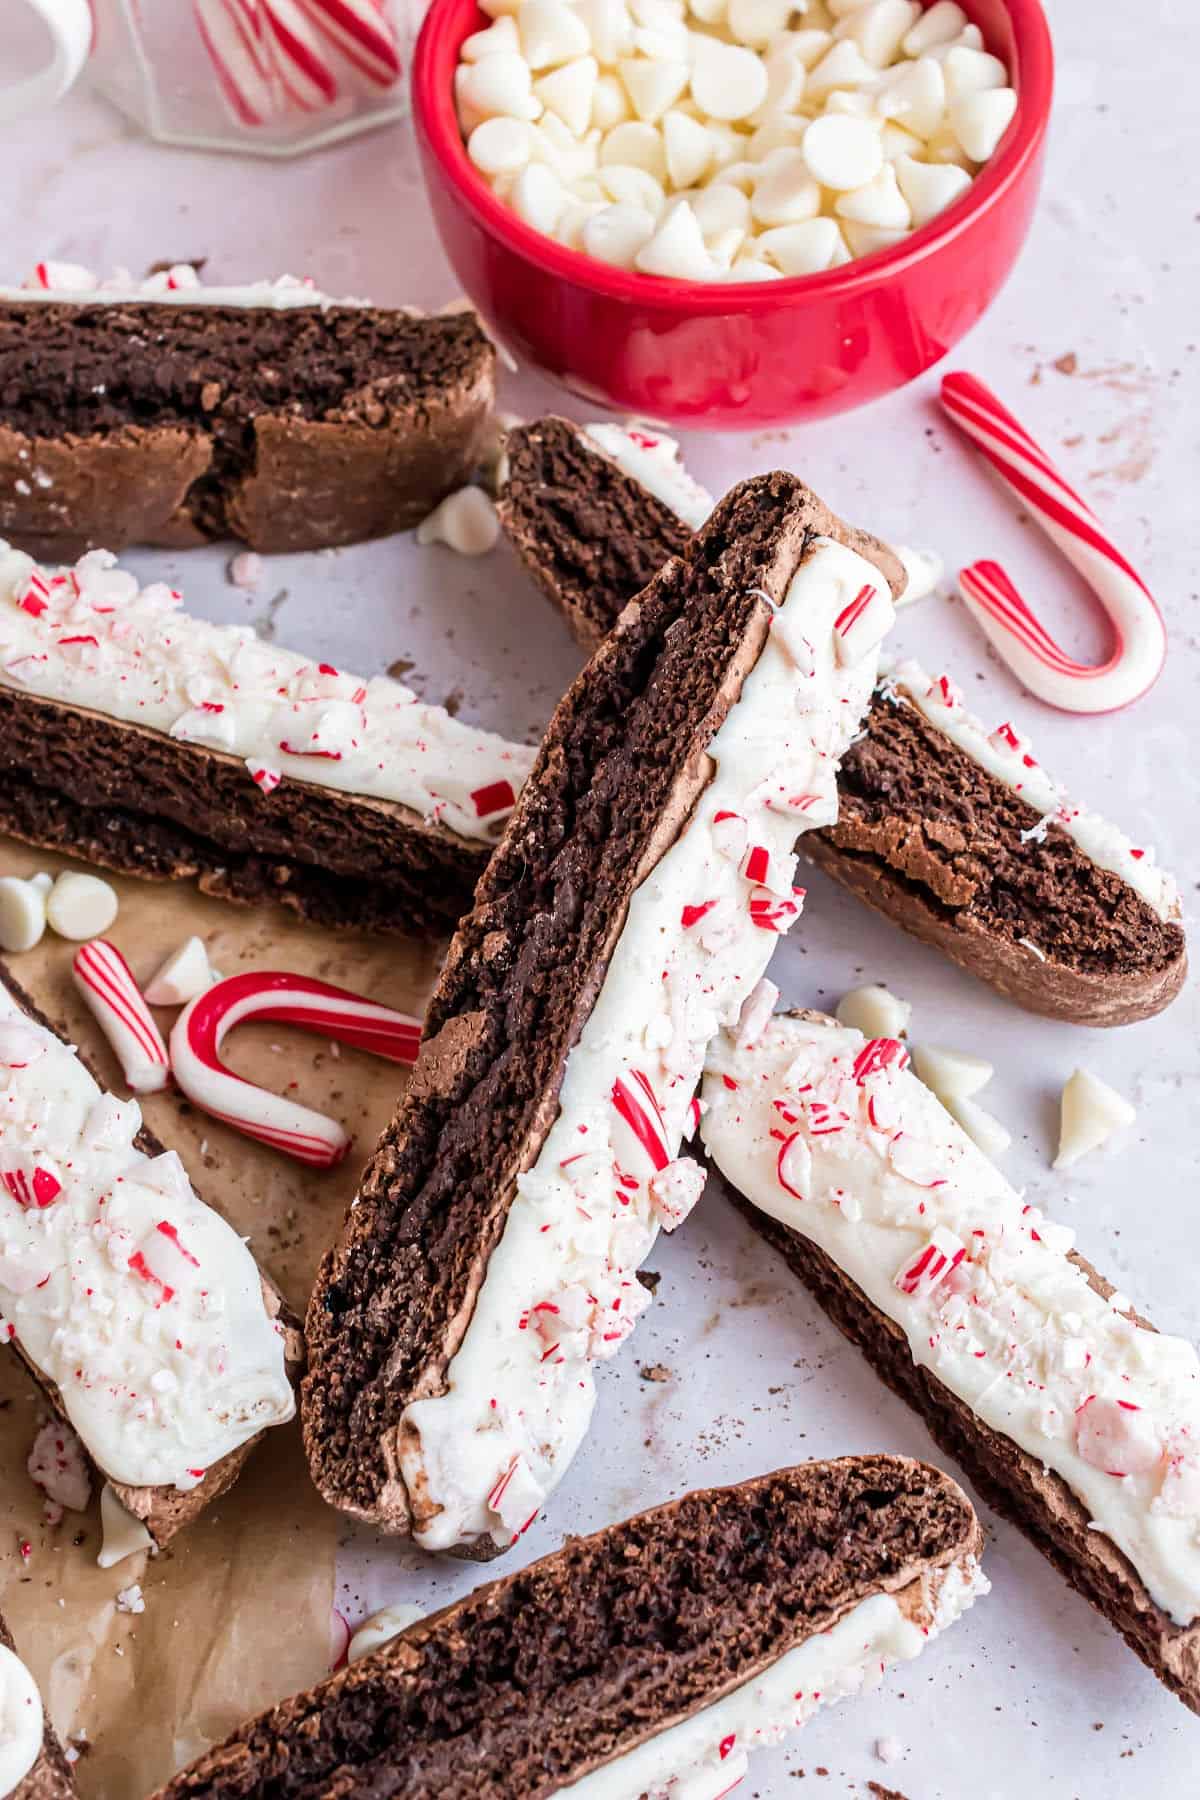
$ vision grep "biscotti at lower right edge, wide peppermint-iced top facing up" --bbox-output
[702,1013,1200,1712]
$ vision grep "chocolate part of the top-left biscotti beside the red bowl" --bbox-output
[0,301,495,562]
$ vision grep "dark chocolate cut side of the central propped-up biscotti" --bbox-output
[304,473,906,1530]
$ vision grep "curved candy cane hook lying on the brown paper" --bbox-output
[171,970,421,1168]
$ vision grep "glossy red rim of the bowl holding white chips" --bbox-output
[412,0,1054,313]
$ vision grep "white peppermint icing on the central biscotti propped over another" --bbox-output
[401,538,894,1550]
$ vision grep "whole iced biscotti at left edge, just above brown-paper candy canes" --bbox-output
[0,545,534,932]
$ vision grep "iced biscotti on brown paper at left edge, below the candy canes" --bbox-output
[0,968,304,1546]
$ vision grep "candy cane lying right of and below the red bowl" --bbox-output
[941,371,1166,713]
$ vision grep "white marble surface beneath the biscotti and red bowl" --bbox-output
[0,0,1200,1800]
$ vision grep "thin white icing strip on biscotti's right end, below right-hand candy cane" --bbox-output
[885,662,1182,920]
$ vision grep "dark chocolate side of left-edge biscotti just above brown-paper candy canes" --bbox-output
[0,688,489,936]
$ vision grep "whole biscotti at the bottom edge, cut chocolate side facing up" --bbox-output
[147,1456,988,1800]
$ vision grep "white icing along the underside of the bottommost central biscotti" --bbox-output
[554,1559,990,1800]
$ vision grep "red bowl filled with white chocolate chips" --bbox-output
[412,0,1052,428]
